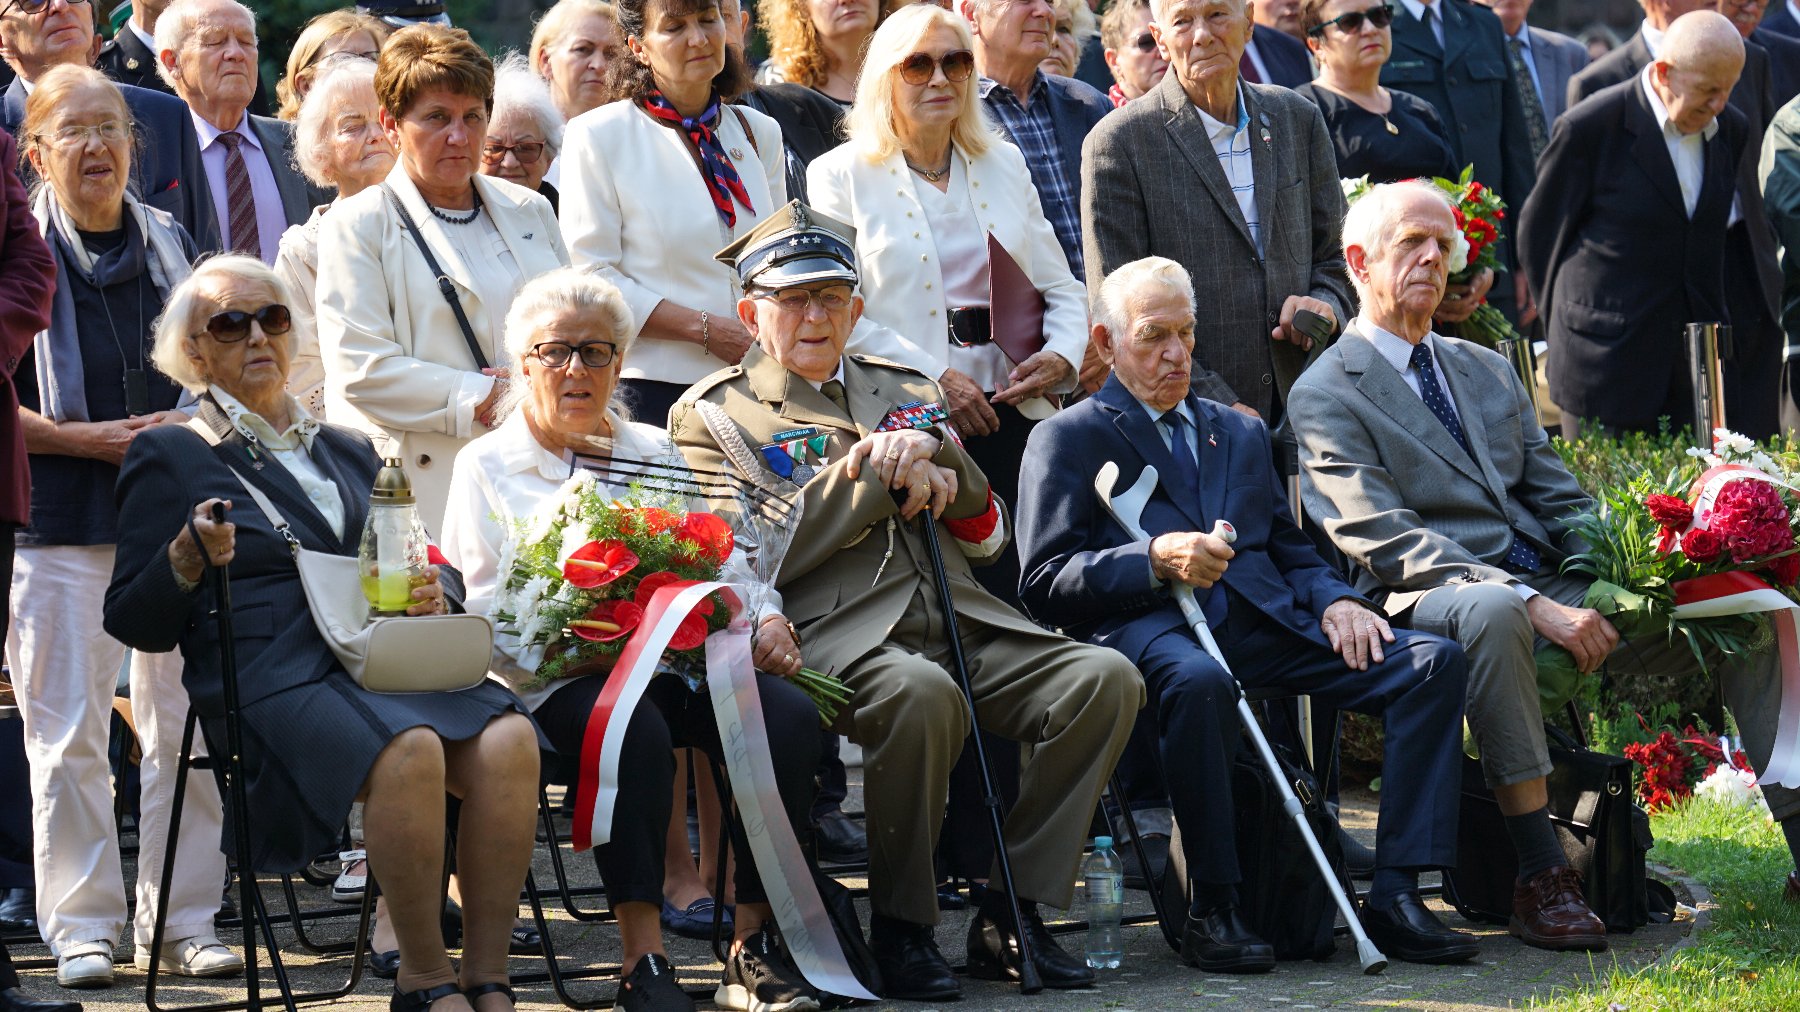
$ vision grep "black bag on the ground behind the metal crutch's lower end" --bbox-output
[1163,731,1350,960]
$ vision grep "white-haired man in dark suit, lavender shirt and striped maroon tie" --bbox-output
[157,0,331,263]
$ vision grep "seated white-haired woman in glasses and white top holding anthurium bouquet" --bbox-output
[443,268,819,1010]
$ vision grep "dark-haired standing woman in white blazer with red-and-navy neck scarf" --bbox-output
[558,0,787,425]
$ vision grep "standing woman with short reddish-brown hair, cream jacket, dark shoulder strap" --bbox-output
[317,25,569,533]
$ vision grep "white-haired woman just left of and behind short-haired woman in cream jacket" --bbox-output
[274,54,394,414]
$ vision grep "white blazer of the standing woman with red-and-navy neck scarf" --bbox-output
[556,101,787,387]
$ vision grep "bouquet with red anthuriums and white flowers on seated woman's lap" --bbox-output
[493,470,848,720]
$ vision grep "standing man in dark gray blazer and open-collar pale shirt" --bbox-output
[1082,0,1352,425]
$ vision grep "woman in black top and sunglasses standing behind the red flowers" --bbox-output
[1294,0,1462,182]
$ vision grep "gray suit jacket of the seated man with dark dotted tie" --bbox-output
[1289,321,1593,614]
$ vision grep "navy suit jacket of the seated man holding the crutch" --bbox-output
[1015,376,1363,663]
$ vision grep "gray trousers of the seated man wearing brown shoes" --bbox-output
[1400,573,1800,819]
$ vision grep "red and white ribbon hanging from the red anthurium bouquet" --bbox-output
[572,582,877,1001]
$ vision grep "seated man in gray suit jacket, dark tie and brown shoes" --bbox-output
[1291,182,1800,951]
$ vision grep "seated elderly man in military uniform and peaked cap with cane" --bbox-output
[670,202,1143,1001]
